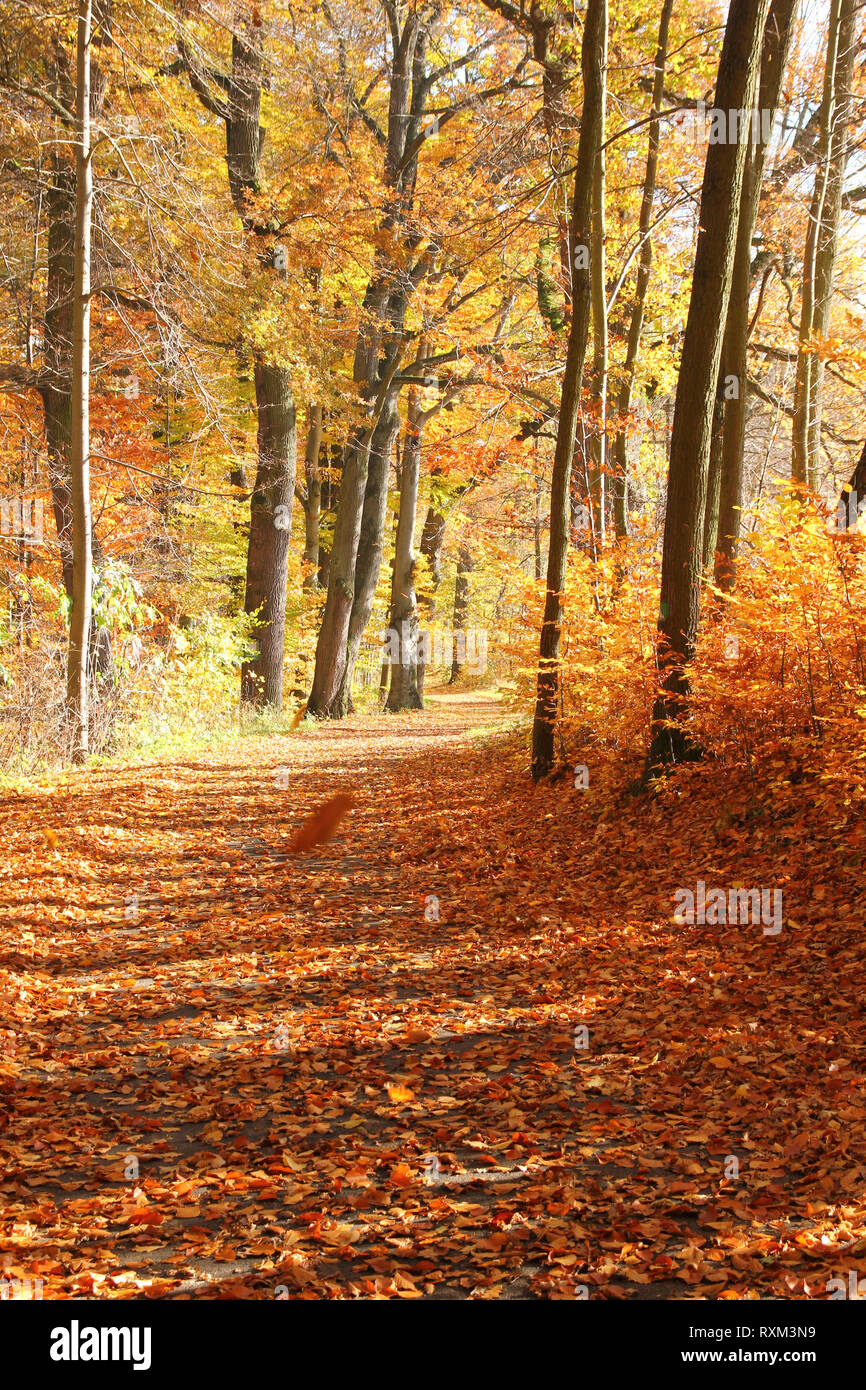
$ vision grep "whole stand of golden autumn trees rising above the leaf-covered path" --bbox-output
[0,0,863,778]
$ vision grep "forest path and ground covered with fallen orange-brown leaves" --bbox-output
[0,695,866,1300]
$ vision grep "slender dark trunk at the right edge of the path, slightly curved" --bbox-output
[532,0,607,781]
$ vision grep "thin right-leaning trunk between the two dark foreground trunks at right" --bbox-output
[613,0,674,537]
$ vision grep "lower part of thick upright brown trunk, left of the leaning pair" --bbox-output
[240,361,296,709]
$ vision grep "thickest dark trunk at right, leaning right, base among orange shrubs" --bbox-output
[645,0,769,777]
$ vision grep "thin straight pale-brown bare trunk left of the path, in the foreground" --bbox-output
[67,0,93,763]
